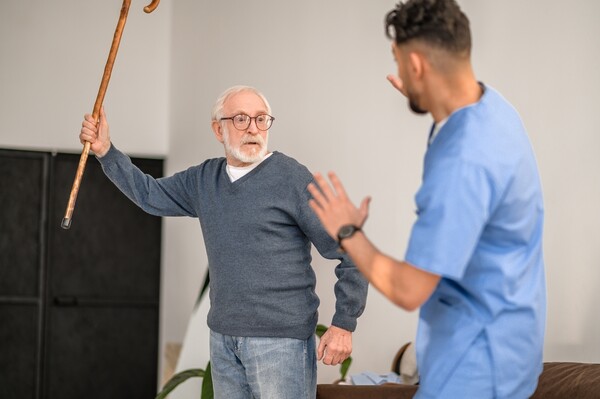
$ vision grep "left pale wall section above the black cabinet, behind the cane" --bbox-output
[0,0,171,156]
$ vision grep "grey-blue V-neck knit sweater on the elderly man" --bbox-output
[99,146,367,339]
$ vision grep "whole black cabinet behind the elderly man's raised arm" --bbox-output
[0,150,163,399]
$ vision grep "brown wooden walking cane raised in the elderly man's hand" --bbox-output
[61,0,160,229]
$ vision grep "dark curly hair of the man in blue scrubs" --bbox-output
[385,0,471,55]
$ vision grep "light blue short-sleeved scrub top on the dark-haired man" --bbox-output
[405,86,546,398]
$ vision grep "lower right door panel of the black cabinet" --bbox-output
[45,305,158,399]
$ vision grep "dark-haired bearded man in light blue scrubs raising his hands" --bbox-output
[309,0,546,399]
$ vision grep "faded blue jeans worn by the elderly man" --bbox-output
[210,331,317,399]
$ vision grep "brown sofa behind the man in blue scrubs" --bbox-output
[317,347,600,399]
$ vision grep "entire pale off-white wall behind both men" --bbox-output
[0,0,600,388]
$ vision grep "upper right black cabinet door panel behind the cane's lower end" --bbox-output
[49,154,162,299]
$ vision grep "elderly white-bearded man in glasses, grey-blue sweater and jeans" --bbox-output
[80,86,367,399]
